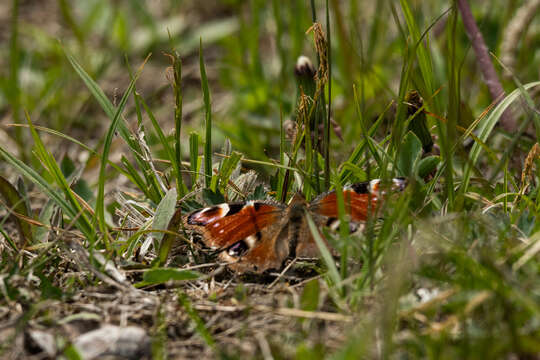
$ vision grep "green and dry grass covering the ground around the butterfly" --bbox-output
[0,0,540,359]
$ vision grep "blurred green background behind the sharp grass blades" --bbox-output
[0,0,540,166]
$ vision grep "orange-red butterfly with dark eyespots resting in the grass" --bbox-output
[183,178,407,273]
